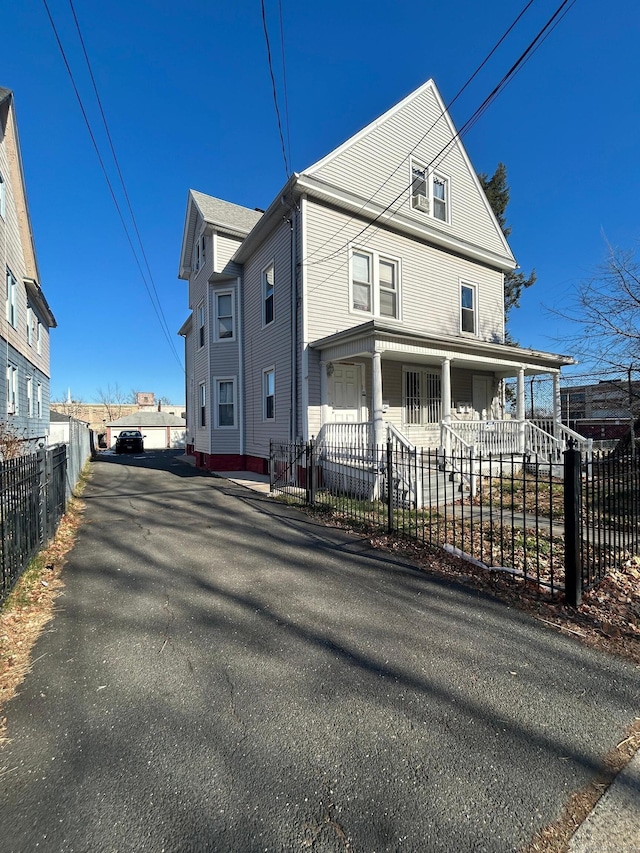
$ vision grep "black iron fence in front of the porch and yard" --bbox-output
[270,441,640,604]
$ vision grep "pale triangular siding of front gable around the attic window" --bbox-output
[309,86,506,256]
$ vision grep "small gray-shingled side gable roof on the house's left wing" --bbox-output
[178,190,262,278]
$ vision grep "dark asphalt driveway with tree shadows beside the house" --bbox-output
[0,452,640,853]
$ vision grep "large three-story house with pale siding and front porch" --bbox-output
[179,81,573,471]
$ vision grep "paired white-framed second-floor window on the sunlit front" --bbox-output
[351,249,400,320]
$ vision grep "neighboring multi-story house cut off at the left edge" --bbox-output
[0,87,56,446]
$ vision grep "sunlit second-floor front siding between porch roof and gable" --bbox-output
[306,202,504,341]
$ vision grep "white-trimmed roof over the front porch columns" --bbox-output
[309,320,575,376]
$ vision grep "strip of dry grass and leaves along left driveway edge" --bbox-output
[0,477,86,745]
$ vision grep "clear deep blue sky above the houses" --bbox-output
[0,0,640,402]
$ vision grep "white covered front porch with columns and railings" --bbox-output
[307,320,590,464]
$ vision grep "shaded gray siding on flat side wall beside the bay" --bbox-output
[243,222,292,458]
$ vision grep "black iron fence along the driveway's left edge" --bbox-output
[0,444,67,602]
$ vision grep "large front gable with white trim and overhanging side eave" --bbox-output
[234,80,517,271]
